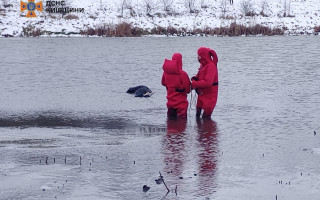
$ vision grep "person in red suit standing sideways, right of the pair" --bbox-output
[191,47,218,118]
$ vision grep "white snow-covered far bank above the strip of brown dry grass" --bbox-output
[0,0,320,37]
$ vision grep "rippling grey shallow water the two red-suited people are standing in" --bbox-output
[0,37,320,200]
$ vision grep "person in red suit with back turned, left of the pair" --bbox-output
[161,53,190,117]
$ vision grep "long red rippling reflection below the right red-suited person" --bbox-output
[197,119,218,196]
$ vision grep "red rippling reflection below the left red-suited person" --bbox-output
[163,118,187,176]
